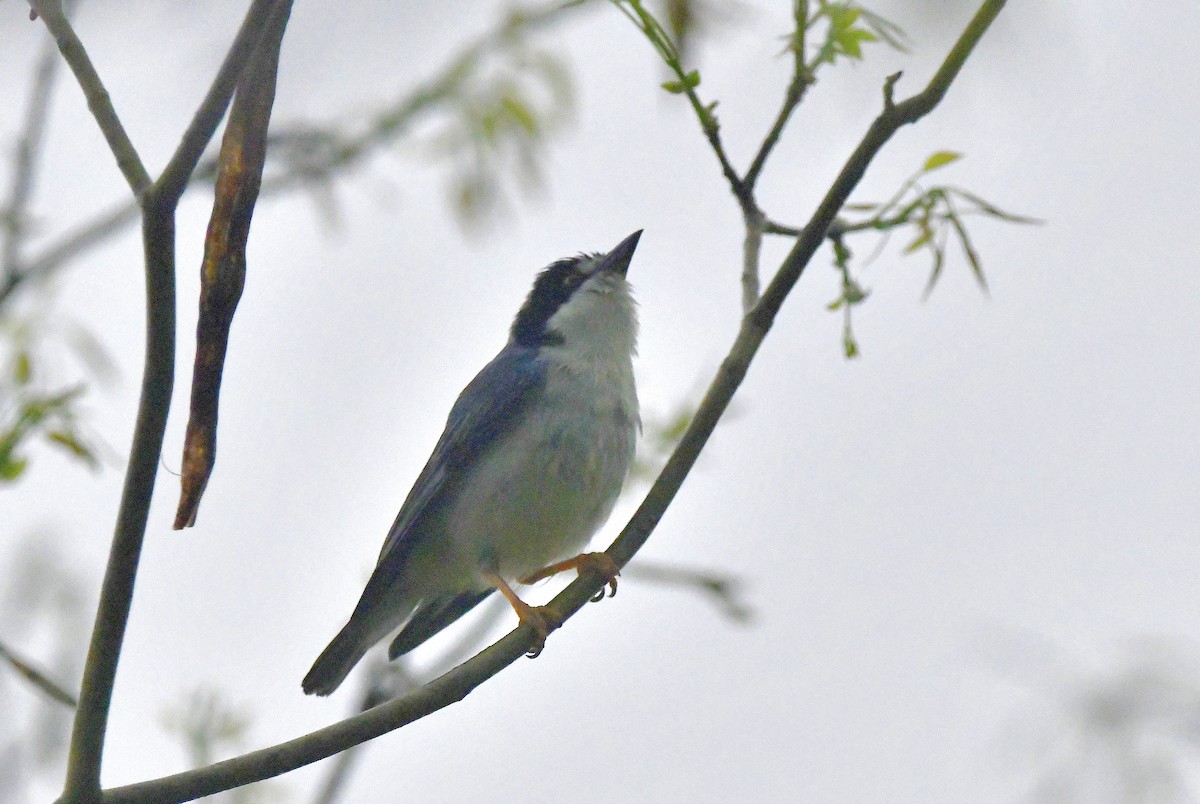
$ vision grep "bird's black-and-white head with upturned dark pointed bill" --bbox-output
[511,230,642,356]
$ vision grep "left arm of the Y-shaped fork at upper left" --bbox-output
[29,0,150,197]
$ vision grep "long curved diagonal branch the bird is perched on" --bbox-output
[93,0,1004,803]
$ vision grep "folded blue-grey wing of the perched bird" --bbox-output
[377,343,546,571]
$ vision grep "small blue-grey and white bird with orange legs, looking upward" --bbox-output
[301,230,642,695]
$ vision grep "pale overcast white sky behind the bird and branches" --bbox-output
[0,0,1200,802]
